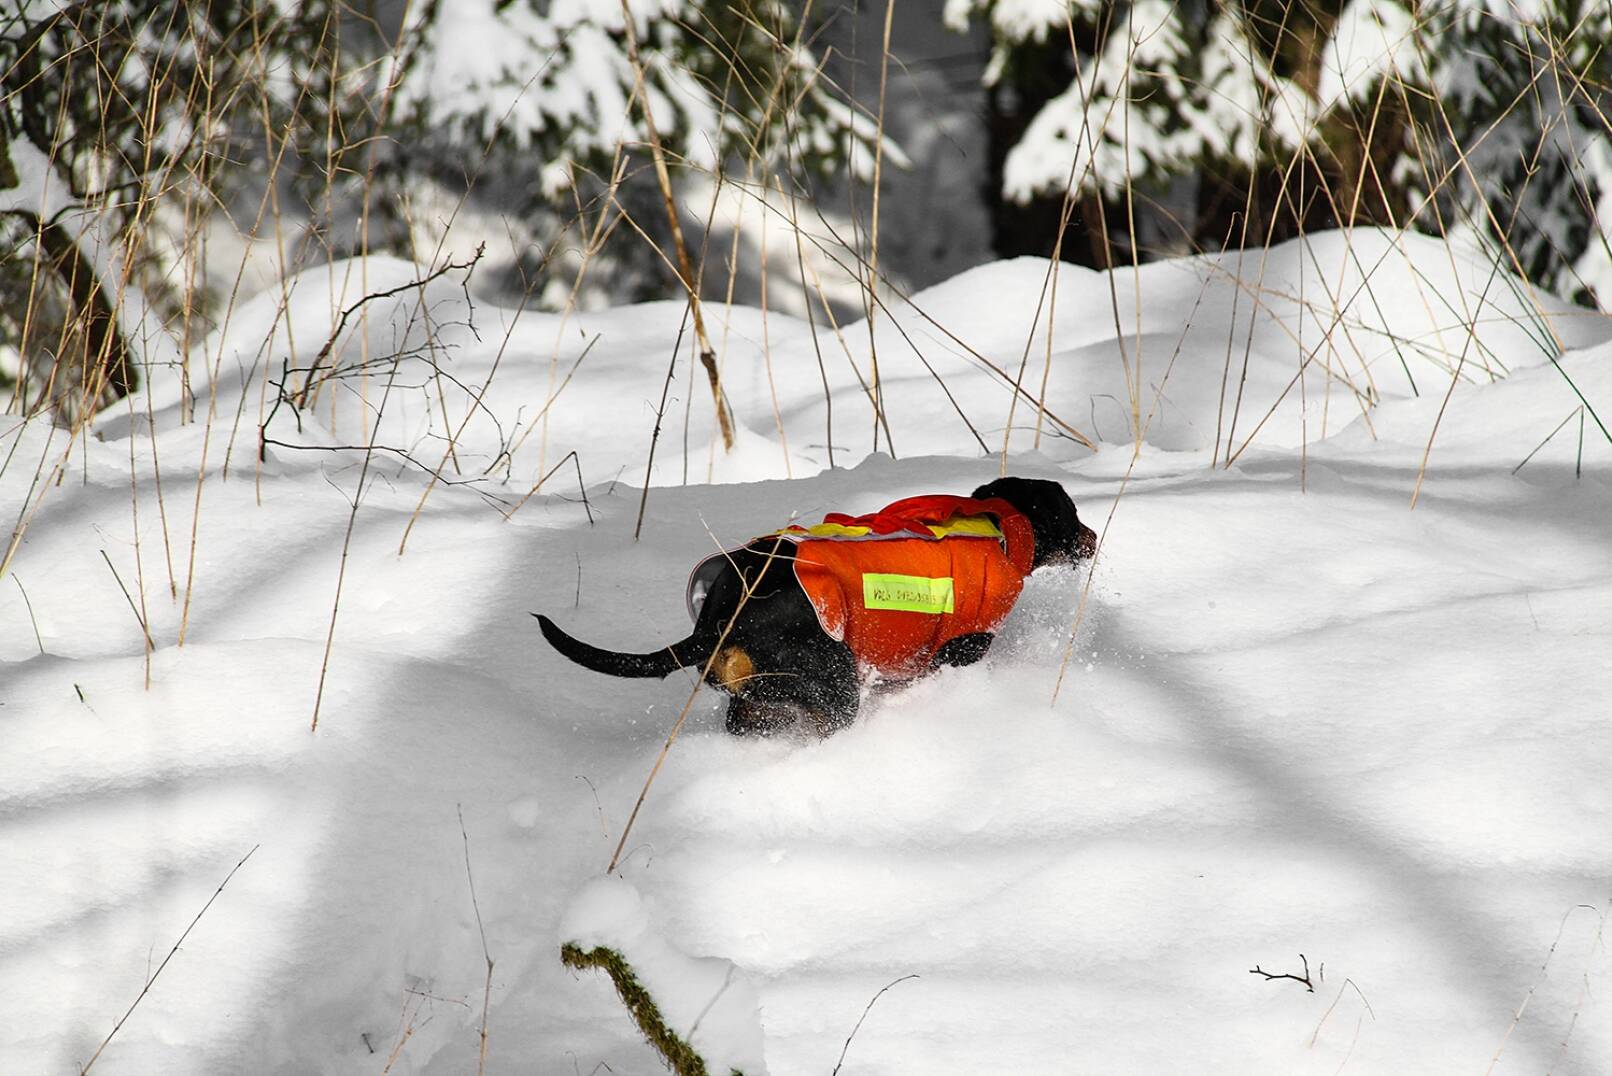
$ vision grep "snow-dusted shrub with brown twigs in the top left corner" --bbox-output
[0,0,373,419]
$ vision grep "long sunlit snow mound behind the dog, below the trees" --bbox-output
[103,227,1612,497]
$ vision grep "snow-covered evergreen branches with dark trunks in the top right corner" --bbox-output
[946,0,1612,305]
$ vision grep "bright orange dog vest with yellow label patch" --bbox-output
[779,495,1035,678]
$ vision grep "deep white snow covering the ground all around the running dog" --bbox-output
[0,231,1612,1076]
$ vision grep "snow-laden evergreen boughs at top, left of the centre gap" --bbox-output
[397,0,874,197]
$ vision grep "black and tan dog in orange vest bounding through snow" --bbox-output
[534,478,1096,732]
